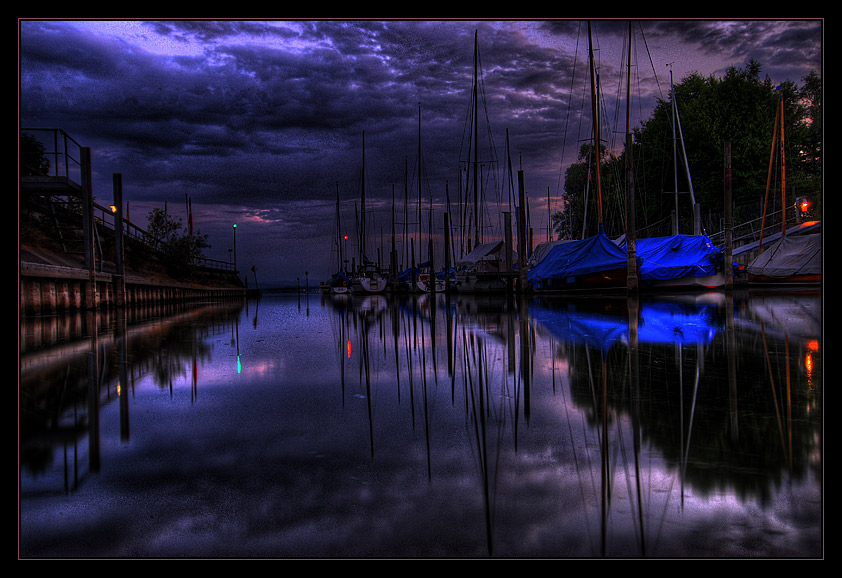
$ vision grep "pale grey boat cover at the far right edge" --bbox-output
[746,234,822,279]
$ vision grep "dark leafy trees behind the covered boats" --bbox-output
[553,61,822,238]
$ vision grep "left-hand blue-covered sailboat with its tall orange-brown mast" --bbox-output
[527,22,629,292]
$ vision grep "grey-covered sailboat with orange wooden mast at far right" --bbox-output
[746,93,823,285]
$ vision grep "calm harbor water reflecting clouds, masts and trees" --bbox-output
[19,291,824,558]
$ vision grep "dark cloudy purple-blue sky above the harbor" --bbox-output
[19,19,824,283]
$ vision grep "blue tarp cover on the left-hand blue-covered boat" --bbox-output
[527,232,628,287]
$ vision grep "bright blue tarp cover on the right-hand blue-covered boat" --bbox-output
[623,235,723,281]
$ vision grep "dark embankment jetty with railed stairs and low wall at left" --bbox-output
[18,129,248,315]
